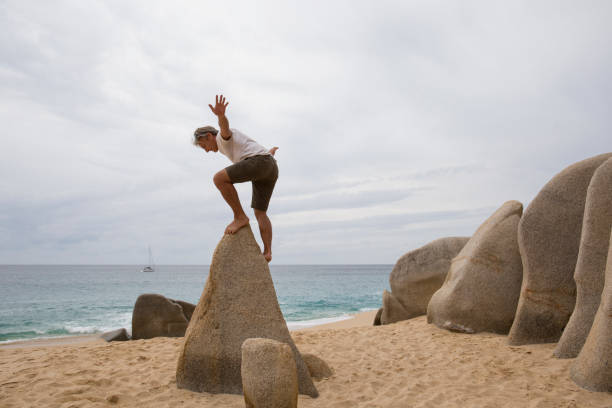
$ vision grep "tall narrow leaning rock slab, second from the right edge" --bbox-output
[554,159,612,358]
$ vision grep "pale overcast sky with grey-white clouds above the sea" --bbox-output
[0,0,612,264]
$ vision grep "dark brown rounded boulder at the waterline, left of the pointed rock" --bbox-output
[132,293,189,340]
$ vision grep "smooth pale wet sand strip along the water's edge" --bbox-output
[0,310,376,349]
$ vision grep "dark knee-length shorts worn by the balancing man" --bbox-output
[225,155,278,211]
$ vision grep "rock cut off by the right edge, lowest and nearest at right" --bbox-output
[570,230,612,392]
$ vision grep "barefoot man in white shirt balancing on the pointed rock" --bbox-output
[193,95,278,262]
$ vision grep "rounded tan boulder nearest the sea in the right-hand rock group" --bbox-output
[389,237,470,320]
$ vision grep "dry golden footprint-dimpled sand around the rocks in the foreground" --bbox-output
[0,311,612,408]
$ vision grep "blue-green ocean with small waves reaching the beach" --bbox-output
[0,265,393,342]
